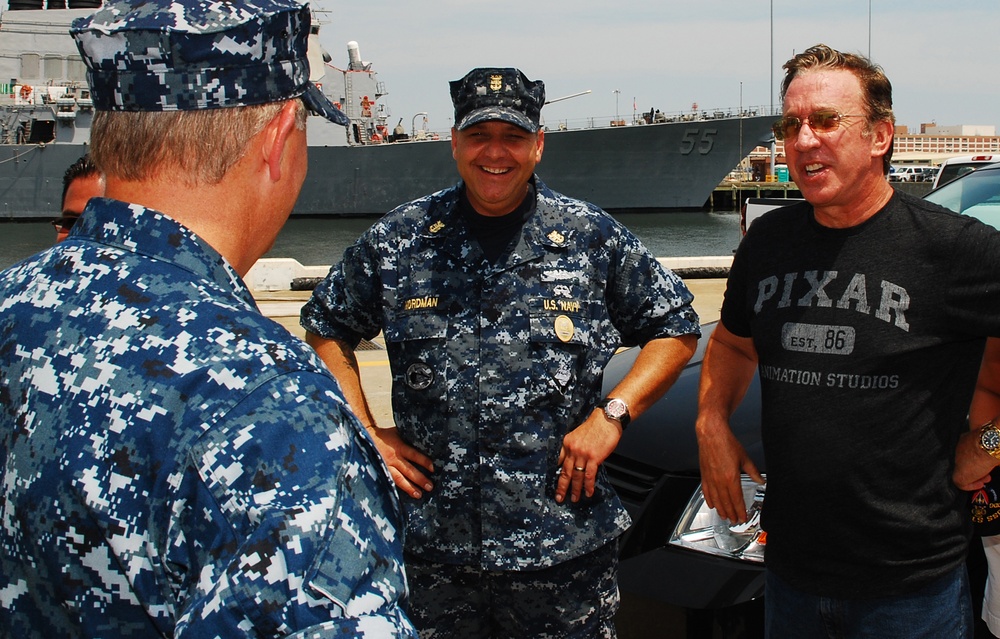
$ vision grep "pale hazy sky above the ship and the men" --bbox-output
[312,0,1000,132]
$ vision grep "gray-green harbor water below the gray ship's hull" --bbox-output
[0,211,740,268]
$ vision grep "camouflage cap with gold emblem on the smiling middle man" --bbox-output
[450,69,545,133]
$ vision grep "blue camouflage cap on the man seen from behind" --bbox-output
[70,0,348,125]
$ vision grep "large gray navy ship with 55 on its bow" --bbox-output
[0,0,775,219]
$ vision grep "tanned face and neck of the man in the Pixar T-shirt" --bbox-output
[782,69,892,228]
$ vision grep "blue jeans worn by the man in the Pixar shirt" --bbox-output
[764,564,973,639]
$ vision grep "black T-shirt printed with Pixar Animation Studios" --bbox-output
[722,193,1000,598]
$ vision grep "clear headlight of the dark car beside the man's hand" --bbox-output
[670,475,767,563]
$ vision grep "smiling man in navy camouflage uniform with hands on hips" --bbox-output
[302,68,699,639]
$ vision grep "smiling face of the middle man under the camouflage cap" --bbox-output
[451,120,545,216]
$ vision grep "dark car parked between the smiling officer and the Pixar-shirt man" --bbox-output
[604,323,766,639]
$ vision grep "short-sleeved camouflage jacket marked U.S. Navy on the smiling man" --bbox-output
[302,177,699,570]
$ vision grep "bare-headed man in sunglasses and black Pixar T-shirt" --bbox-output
[696,45,1000,639]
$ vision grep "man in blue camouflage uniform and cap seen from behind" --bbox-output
[0,0,415,639]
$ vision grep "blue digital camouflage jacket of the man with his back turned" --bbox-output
[0,199,414,639]
